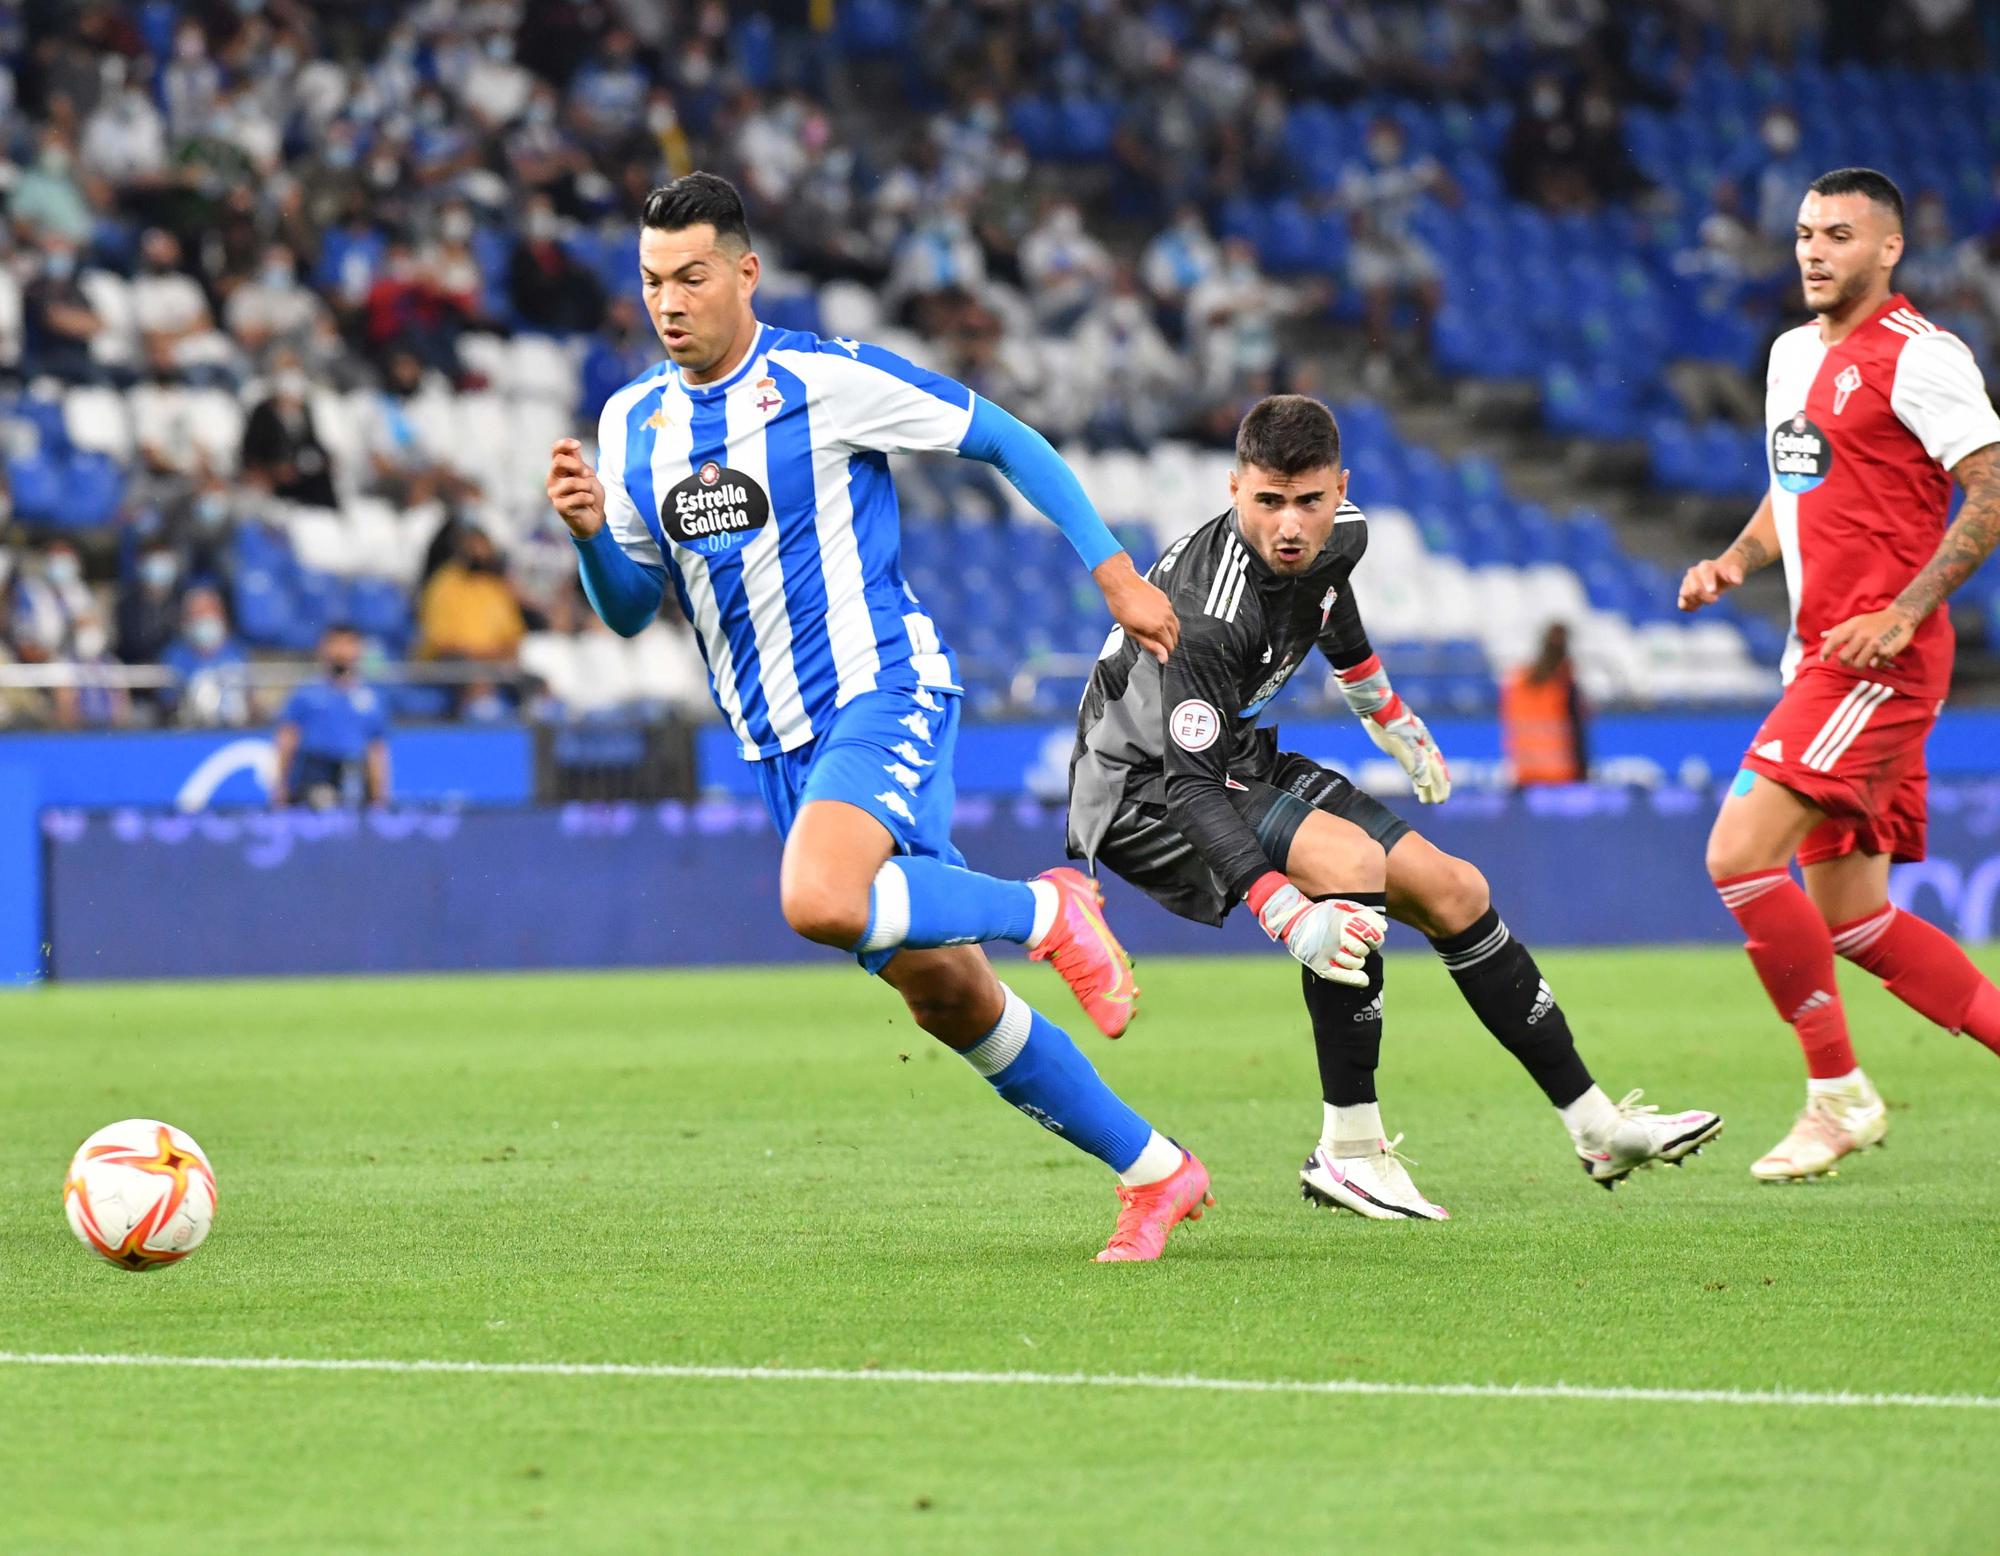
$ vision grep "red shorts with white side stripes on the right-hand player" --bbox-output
[1744,664,1944,864]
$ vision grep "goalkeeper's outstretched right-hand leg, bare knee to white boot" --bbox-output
[1388,832,1722,1184]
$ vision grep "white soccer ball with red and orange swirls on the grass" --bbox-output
[62,1118,216,1270]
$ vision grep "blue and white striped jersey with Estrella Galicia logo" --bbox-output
[598,324,972,760]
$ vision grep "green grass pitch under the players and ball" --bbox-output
[0,950,2000,1556]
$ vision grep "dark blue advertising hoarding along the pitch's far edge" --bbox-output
[42,782,2000,978]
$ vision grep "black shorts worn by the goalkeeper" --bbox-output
[1098,752,1410,924]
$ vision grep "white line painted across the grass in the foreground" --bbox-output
[0,1350,2000,1410]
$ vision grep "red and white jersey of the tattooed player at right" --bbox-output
[1764,294,2000,698]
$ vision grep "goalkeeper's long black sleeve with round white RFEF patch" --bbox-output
[1160,616,1272,900]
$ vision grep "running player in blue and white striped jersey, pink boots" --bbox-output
[548,172,1214,1262]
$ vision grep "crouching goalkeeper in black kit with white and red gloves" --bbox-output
[1070,394,1722,1220]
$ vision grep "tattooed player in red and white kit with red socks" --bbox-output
[1680,168,2000,1182]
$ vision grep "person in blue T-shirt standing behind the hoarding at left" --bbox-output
[270,622,390,810]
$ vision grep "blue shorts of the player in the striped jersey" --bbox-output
[756,688,966,972]
